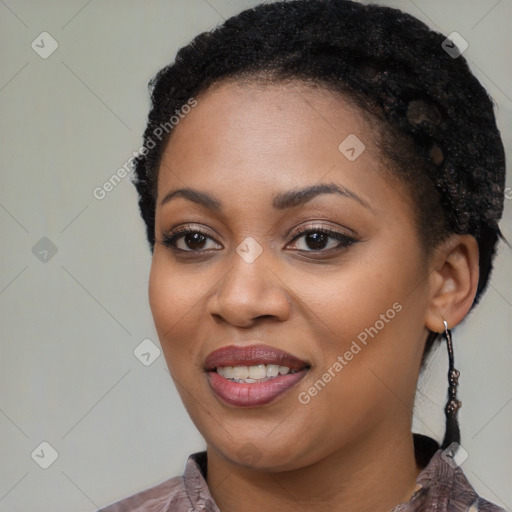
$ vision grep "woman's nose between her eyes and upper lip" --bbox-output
[207,248,290,328]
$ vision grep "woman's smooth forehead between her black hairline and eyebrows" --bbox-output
[158,82,408,218]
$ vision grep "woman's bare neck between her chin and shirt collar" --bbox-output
[207,432,421,512]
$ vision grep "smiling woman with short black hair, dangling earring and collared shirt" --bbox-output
[98,0,505,512]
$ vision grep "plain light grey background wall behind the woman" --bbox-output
[0,0,512,512]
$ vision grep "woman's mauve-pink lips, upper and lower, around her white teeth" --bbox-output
[205,345,310,407]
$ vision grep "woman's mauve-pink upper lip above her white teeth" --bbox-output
[205,344,310,371]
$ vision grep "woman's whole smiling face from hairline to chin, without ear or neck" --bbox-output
[149,83,429,471]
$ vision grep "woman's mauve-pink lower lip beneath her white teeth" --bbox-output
[208,368,308,407]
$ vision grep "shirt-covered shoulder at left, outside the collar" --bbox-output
[99,476,191,512]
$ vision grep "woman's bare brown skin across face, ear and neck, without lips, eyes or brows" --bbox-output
[149,82,478,512]
